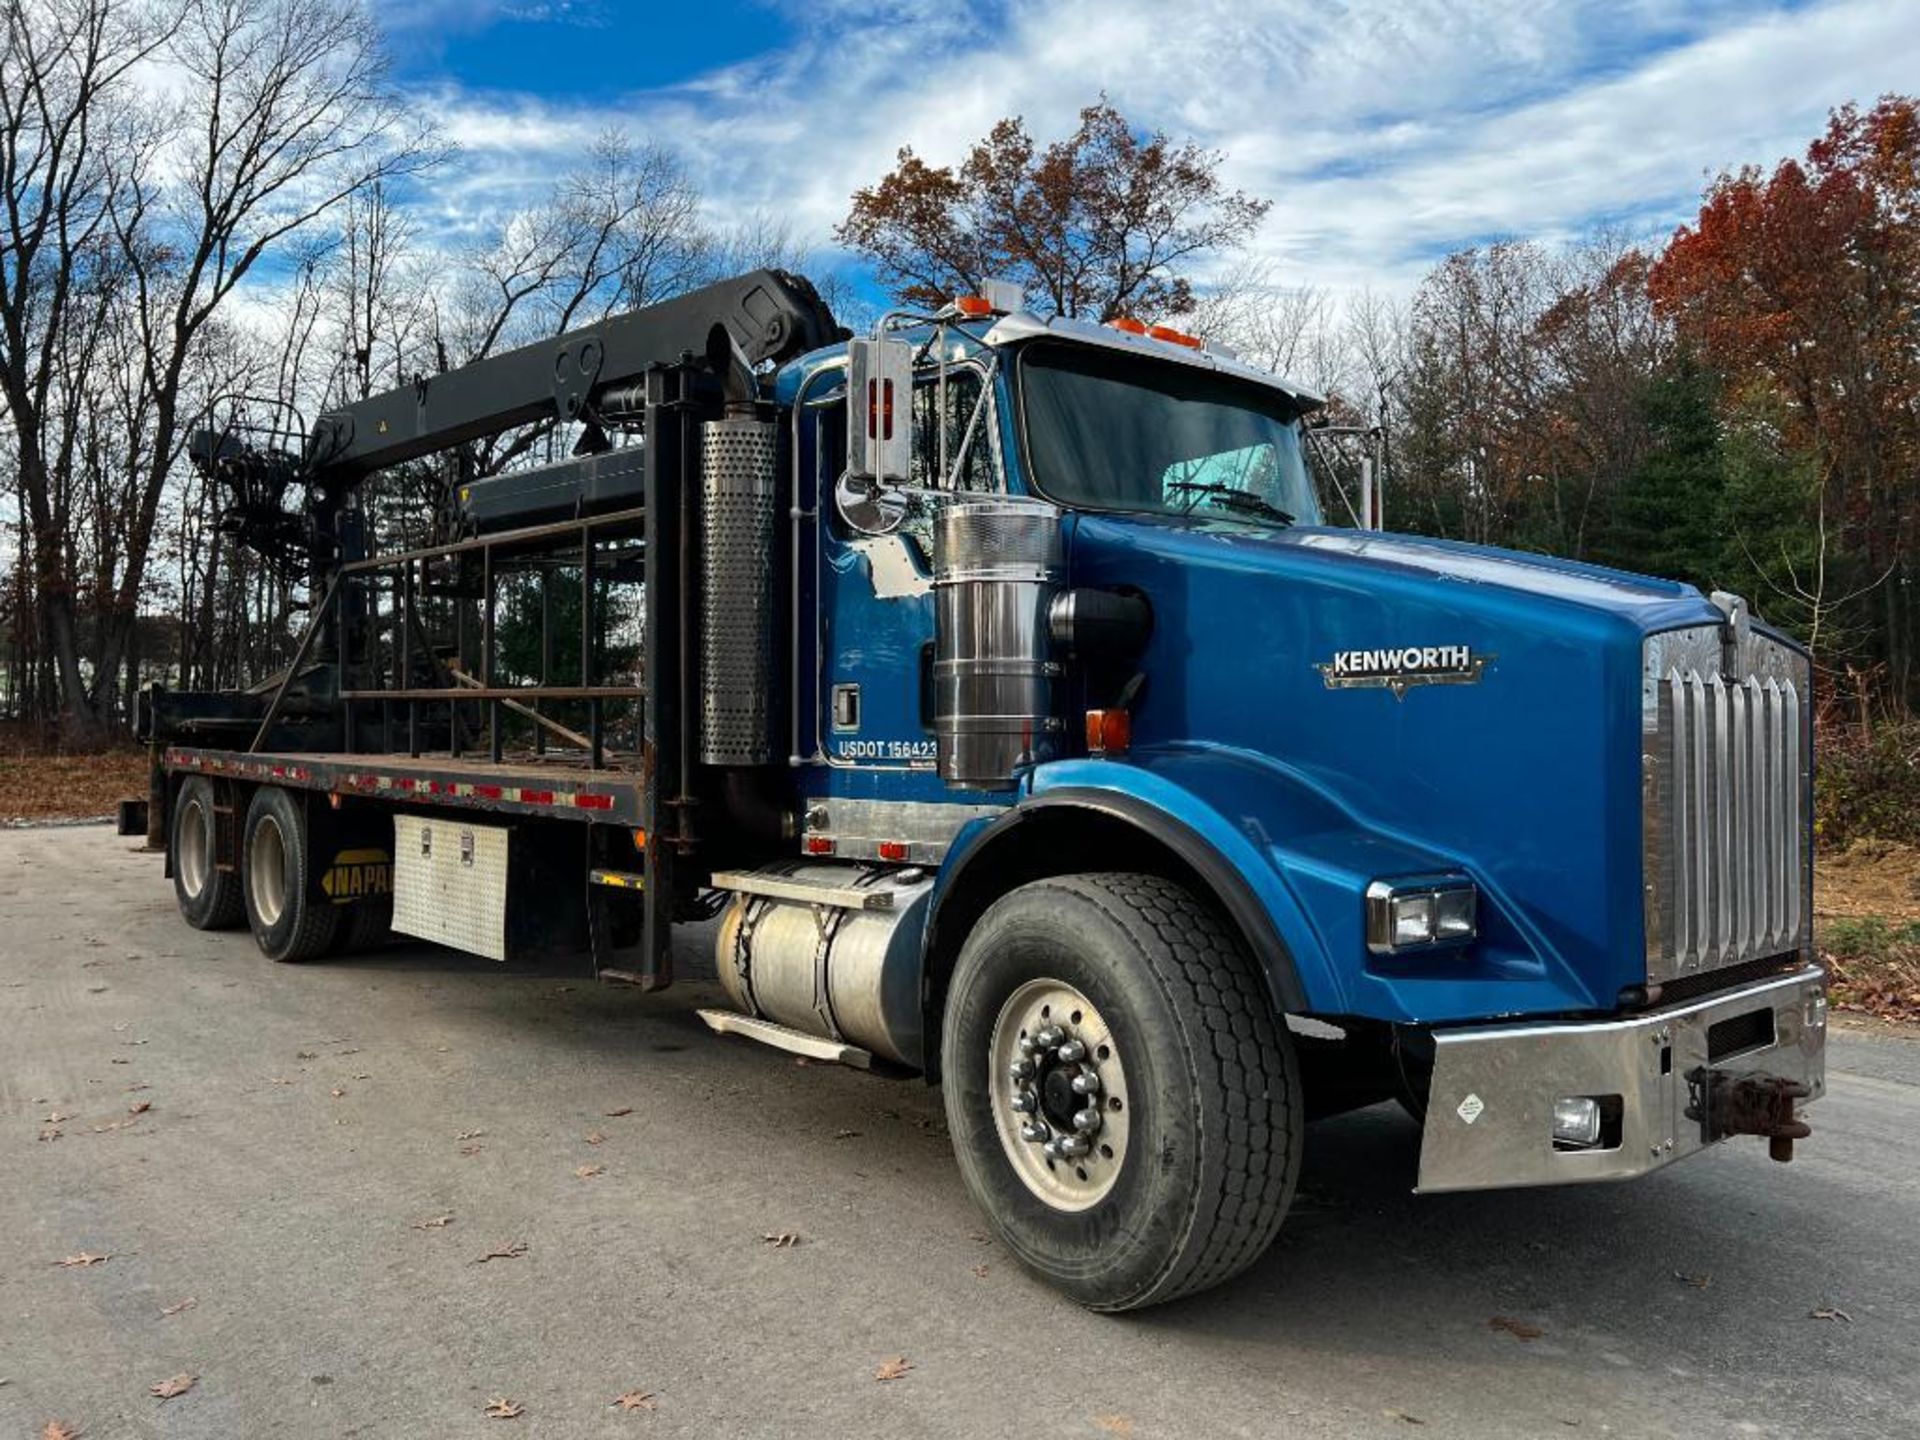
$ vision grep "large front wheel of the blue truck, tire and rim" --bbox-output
[941,874,1304,1309]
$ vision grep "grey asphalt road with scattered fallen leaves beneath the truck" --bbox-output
[0,828,1920,1440]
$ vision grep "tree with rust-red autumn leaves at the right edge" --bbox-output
[1649,96,1920,707]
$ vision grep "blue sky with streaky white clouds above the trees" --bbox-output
[380,0,1920,292]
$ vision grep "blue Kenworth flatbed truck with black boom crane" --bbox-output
[127,271,1826,1309]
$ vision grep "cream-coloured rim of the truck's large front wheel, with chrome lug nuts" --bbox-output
[987,979,1133,1212]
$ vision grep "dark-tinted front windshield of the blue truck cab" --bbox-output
[1020,344,1319,524]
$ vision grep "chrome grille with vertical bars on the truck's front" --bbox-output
[1642,614,1811,983]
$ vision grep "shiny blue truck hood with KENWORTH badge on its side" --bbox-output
[1069,515,1720,1018]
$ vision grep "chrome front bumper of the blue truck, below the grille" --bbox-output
[1417,966,1826,1192]
